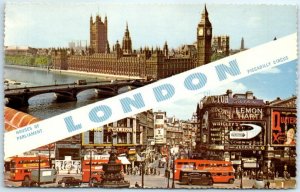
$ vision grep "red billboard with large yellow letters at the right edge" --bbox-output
[271,110,297,146]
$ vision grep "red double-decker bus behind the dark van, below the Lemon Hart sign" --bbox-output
[175,159,235,183]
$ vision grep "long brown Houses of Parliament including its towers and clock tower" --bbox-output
[52,6,229,79]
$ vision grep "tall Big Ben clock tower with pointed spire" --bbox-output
[196,5,212,67]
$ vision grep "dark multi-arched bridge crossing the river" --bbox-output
[4,80,153,108]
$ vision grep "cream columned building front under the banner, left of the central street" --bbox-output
[82,110,154,160]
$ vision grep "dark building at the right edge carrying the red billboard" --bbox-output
[264,96,297,177]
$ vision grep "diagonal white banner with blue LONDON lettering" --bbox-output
[4,33,297,158]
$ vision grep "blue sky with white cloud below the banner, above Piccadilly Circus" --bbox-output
[154,61,297,120]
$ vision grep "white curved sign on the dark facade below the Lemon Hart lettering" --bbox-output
[229,124,262,139]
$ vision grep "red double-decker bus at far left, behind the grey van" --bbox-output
[10,156,50,181]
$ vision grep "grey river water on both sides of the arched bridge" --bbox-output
[4,66,125,119]
